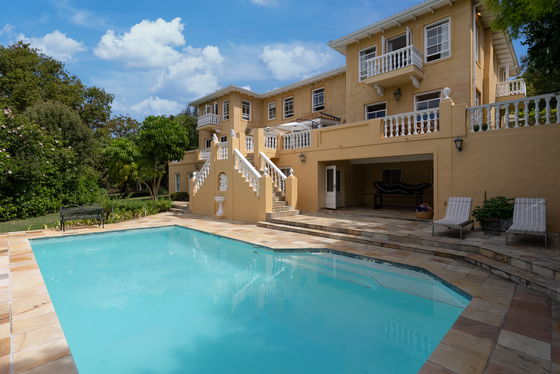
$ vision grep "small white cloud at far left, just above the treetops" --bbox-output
[17,30,86,61]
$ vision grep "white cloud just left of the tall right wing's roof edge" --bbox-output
[260,43,334,80]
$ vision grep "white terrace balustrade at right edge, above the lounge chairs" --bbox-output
[467,93,560,132]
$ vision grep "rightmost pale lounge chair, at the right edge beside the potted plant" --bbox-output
[506,197,548,248]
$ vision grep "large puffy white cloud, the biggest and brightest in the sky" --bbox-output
[94,17,185,67]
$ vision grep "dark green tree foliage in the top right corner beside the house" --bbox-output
[486,0,560,95]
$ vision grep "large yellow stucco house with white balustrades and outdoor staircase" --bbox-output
[169,0,560,232]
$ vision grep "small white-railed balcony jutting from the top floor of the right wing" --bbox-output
[365,45,424,91]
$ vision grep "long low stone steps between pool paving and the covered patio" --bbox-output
[258,213,560,301]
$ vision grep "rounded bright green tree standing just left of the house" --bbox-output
[135,116,189,200]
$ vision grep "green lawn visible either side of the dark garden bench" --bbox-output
[0,197,171,233]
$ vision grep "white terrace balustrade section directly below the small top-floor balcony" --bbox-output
[383,109,439,138]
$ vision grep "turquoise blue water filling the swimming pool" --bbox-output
[32,227,469,374]
